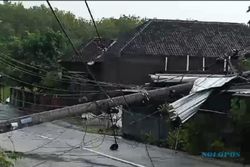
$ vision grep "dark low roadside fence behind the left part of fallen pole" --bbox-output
[10,87,128,112]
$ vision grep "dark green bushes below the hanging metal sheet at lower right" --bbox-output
[159,98,250,158]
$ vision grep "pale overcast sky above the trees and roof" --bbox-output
[12,1,250,23]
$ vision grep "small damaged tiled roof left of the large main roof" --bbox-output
[64,38,113,62]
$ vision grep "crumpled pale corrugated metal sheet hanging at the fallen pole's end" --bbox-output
[169,76,236,123]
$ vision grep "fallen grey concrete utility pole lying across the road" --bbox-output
[0,82,193,133]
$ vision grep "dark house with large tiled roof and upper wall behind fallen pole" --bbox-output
[62,19,250,85]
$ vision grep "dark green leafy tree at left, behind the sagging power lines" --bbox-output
[3,29,67,89]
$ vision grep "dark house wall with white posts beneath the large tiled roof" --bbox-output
[100,55,228,85]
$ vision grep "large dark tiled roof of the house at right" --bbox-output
[108,19,250,57]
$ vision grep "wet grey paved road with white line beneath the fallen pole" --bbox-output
[0,121,246,167]
